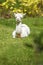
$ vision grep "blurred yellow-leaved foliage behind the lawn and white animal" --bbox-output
[0,0,43,18]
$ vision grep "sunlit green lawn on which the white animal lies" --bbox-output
[0,17,43,65]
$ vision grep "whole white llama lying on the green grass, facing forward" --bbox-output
[12,13,30,38]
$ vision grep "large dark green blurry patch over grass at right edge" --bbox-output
[33,31,43,52]
